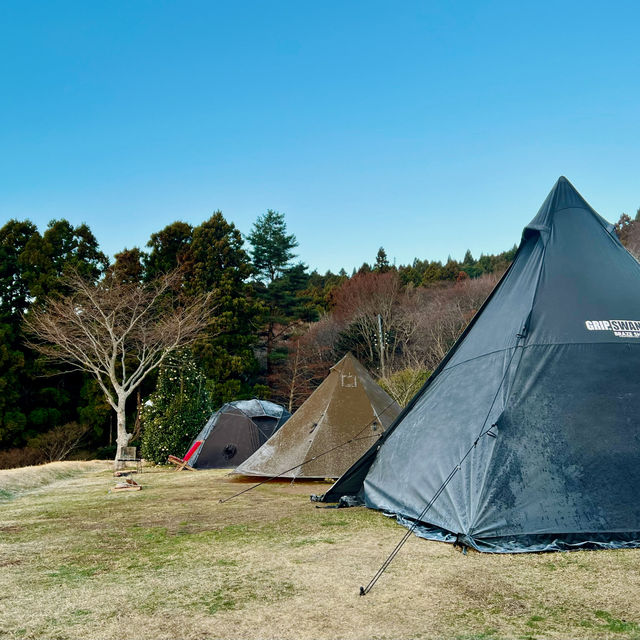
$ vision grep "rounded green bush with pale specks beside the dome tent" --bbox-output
[141,352,211,464]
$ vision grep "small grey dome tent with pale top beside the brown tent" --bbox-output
[190,398,291,469]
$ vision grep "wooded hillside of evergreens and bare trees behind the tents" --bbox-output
[0,210,640,468]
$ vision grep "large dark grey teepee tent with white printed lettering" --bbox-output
[323,177,640,552]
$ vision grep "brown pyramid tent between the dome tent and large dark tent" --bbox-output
[235,353,400,478]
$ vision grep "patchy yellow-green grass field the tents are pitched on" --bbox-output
[0,463,640,640]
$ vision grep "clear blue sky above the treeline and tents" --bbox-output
[0,0,640,271]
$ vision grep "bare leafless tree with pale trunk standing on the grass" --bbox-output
[25,272,214,468]
